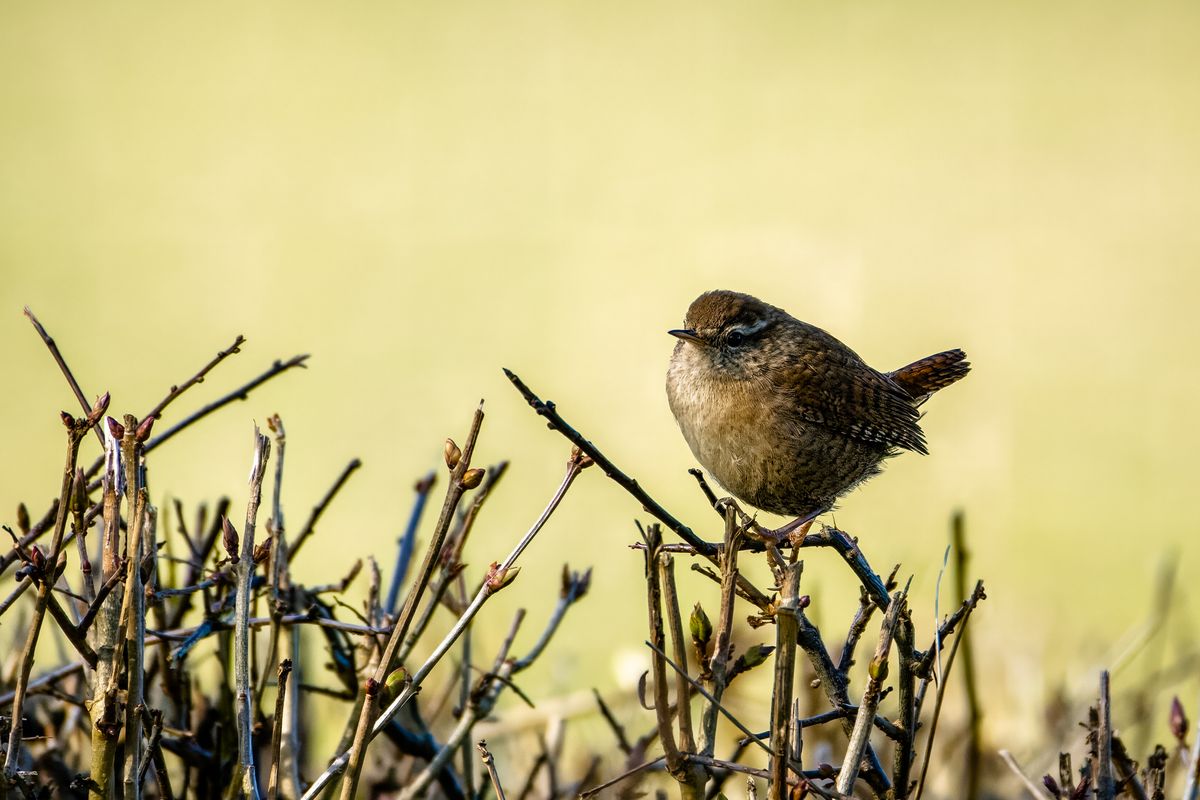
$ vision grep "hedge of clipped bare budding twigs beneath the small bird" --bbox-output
[0,311,1200,800]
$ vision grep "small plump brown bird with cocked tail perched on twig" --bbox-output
[667,290,971,535]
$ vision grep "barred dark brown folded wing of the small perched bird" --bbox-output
[775,329,929,453]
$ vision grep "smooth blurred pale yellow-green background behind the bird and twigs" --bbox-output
[0,1,1200,762]
